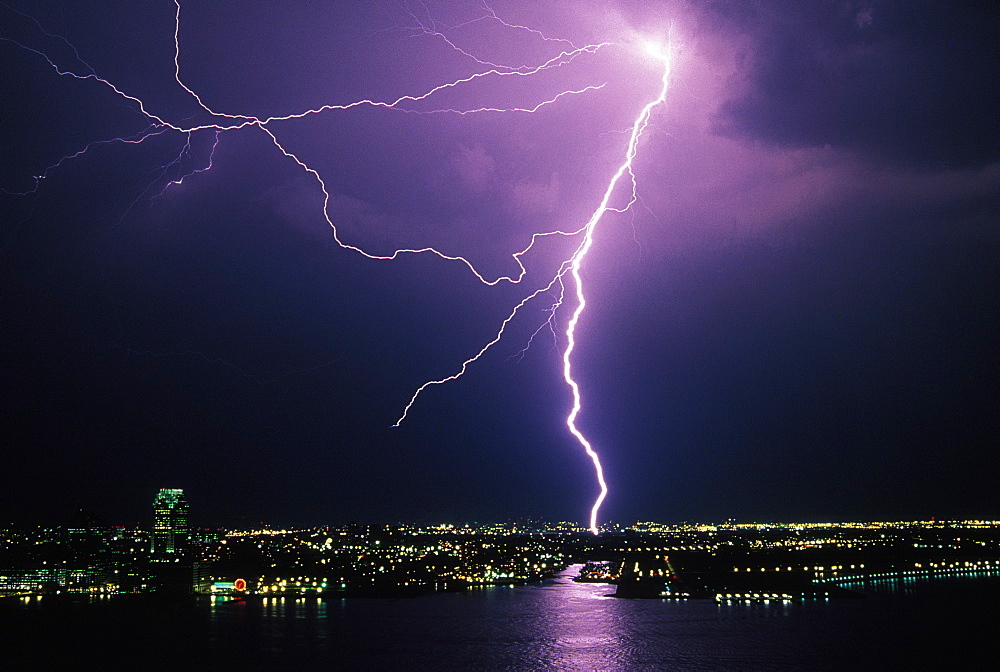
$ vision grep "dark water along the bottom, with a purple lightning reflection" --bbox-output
[0,571,1000,670]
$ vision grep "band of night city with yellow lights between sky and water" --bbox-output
[0,488,1000,606]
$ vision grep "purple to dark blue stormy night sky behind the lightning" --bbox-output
[0,0,1000,525]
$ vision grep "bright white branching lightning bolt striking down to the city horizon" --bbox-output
[0,0,671,534]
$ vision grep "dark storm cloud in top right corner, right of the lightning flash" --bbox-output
[712,0,1000,169]
